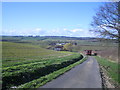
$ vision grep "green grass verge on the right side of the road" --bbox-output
[95,56,120,85]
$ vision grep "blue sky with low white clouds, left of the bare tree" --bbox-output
[0,2,102,37]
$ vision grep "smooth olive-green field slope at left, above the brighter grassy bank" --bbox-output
[2,42,73,65]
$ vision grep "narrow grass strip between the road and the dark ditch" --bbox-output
[17,57,87,88]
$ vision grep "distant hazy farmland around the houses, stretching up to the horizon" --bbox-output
[2,36,118,62]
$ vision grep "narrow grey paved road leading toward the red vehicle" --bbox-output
[40,56,102,88]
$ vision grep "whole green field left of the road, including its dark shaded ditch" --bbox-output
[0,42,82,89]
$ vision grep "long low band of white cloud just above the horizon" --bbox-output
[2,27,93,37]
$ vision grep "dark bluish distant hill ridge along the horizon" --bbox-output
[2,36,96,42]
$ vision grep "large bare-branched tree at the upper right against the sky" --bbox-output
[90,2,120,42]
